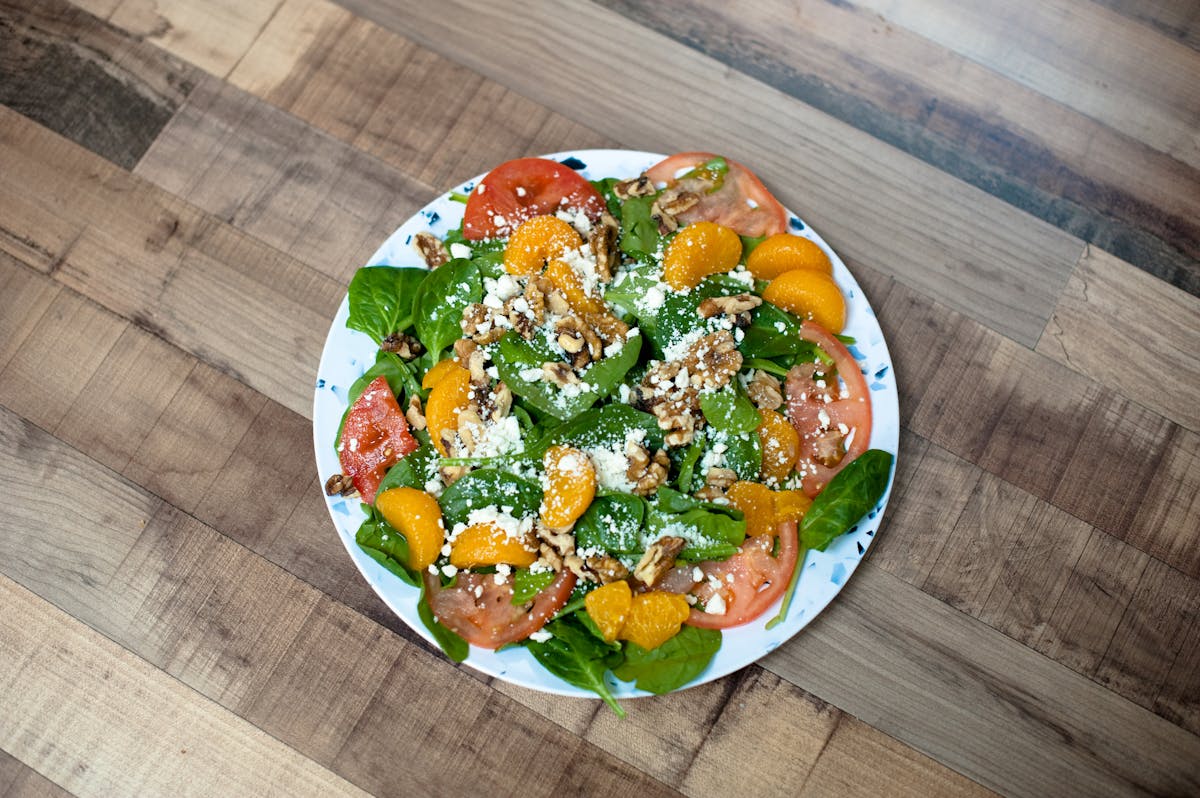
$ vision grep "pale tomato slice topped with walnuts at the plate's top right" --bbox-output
[646,152,787,238]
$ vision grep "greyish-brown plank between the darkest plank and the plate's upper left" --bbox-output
[136,71,433,283]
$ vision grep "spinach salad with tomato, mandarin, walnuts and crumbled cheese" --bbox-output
[318,152,893,714]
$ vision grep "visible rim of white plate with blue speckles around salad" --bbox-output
[312,150,900,698]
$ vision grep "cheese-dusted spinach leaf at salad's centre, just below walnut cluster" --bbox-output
[492,332,642,420]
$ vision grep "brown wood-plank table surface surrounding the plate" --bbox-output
[0,0,1200,796]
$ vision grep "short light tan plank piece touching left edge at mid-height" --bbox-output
[0,289,128,430]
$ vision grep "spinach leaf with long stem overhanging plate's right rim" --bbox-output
[767,449,893,629]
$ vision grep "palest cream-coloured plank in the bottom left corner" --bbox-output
[0,577,365,798]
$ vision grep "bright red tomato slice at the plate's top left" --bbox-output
[462,158,605,241]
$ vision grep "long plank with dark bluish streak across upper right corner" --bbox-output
[601,0,1200,294]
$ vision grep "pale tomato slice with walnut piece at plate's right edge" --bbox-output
[785,322,871,498]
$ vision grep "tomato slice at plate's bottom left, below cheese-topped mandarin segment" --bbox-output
[424,568,576,649]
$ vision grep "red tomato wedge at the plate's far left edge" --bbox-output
[337,377,419,504]
